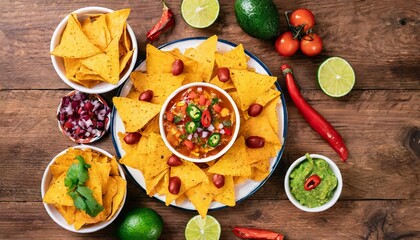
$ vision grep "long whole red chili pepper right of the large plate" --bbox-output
[281,64,349,162]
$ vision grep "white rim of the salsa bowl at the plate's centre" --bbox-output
[159,82,241,162]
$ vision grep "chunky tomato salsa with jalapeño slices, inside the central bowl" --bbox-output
[163,86,236,158]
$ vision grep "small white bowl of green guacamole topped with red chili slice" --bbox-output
[284,153,343,212]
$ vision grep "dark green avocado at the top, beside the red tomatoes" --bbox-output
[235,0,280,40]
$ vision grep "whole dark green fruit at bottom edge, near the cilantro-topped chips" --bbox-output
[118,208,163,240]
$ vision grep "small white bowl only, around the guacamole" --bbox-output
[284,154,343,212]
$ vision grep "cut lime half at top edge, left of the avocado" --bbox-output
[181,0,220,28]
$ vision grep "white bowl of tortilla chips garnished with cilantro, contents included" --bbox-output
[41,145,127,233]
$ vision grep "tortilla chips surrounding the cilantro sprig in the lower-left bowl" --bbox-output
[43,148,127,230]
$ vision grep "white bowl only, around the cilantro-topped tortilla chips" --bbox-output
[41,145,127,233]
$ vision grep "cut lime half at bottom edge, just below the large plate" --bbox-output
[185,215,221,240]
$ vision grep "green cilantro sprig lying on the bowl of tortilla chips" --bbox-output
[64,156,104,217]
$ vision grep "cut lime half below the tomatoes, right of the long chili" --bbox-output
[318,57,356,97]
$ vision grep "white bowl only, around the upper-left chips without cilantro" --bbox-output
[50,7,138,93]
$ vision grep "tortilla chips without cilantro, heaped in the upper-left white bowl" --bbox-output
[51,9,134,88]
